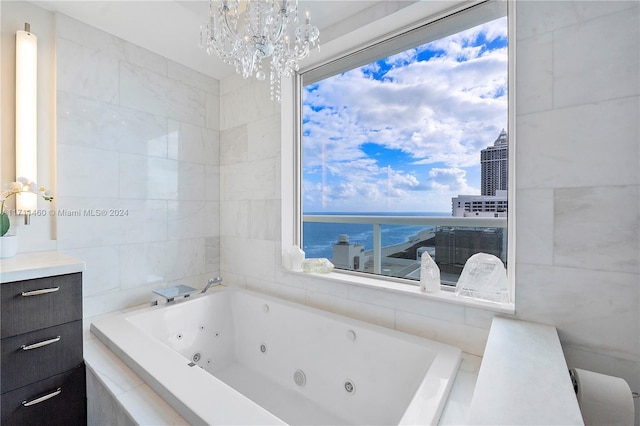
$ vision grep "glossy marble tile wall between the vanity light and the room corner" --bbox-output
[55,15,220,316]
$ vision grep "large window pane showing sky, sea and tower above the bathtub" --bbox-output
[298,2,513,285]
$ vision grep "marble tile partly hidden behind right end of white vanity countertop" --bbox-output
[66,246,120,296]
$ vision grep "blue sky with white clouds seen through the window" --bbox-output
[303,18,507,212]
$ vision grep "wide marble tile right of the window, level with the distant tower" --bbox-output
[516,97,640,190]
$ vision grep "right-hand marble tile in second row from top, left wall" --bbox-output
[119,62,206,126]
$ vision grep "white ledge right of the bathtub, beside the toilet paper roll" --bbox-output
[468,317,584,425]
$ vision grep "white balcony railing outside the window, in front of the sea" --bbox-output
[303,214,507,284]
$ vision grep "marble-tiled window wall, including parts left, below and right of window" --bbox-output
[220,1,640,422]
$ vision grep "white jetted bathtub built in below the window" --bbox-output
[91,286,461,425]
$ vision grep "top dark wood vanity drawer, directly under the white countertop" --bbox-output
[0,272,82,338]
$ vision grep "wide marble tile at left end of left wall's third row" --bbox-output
[57,90,167,157]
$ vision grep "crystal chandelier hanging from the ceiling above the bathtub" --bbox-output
[200,0,320,102]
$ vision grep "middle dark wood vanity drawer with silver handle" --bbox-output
[1,320,82,393]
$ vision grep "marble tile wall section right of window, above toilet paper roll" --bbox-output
[516,1,640,424]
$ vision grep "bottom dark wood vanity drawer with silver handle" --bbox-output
[0,365,87,426]
